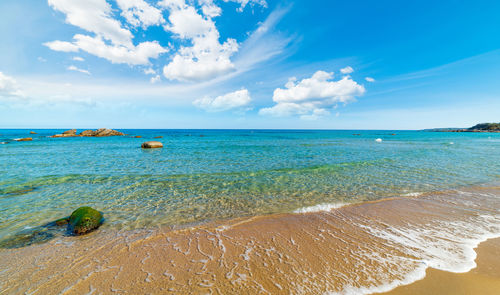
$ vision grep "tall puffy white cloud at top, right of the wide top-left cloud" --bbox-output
[160,0,238,81]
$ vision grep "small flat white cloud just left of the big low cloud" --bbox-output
[193,89,252,112]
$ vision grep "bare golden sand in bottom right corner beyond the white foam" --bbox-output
[384,238,500,295]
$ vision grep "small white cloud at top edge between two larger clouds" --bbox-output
[116,0,165,29]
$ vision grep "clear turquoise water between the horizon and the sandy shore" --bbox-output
[0,130,500,239]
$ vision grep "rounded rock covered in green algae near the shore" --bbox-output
[68,207,103,235]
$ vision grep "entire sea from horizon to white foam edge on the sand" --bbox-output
[0,129,500,294]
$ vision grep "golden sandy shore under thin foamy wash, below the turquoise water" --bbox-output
[0,188,500,294]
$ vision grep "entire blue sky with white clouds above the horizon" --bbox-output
[0,0,500,130]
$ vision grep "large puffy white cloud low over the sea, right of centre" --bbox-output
[259,71,365,119]
